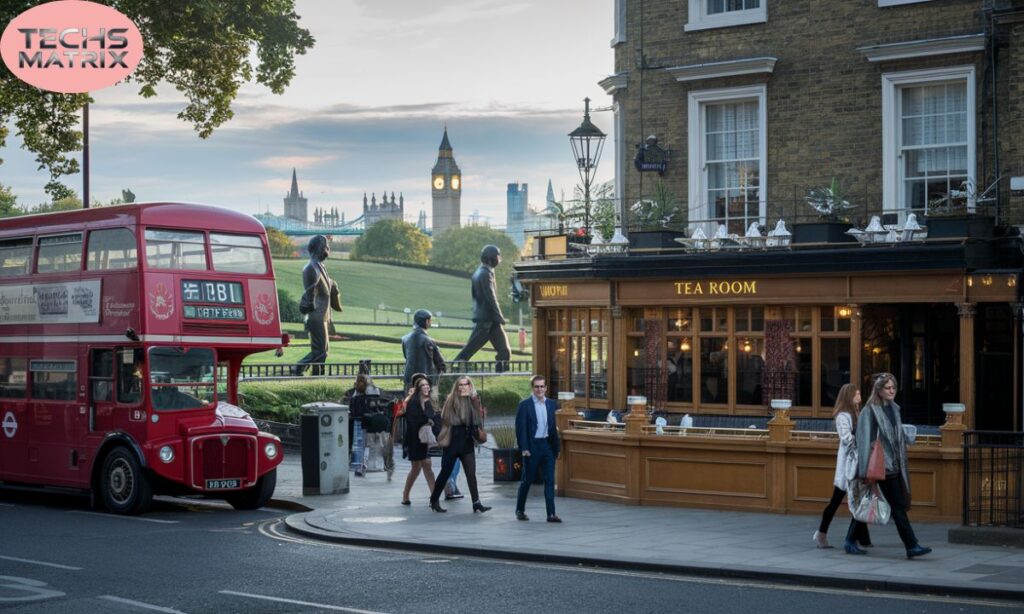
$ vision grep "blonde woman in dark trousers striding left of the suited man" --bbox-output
[430,376,490,514]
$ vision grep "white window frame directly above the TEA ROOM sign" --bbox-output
[687,84,768,232]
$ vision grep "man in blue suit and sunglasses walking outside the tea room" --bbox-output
[515,376,562,522]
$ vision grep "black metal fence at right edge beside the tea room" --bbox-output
[964,431,1024,529]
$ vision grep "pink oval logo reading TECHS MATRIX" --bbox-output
[0,0,142,94]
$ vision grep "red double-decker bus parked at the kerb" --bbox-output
[0,203,284,514]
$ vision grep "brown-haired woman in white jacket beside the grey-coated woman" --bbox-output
[813,384,871,555]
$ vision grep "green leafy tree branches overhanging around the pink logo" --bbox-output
[0,0,314,201]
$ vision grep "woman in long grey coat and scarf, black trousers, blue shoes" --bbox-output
[847,374,932,559]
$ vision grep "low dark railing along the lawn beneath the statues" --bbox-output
[241,360,534,380]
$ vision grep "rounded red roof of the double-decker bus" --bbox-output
[0,203,263,234]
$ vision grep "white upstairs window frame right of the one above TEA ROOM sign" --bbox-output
[882,65,978,216]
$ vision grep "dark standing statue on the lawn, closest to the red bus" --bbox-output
[294,234,341,376]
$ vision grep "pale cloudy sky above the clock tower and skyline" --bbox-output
[0,0,614,226]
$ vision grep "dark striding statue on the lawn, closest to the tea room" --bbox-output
[455,246,512,372]
